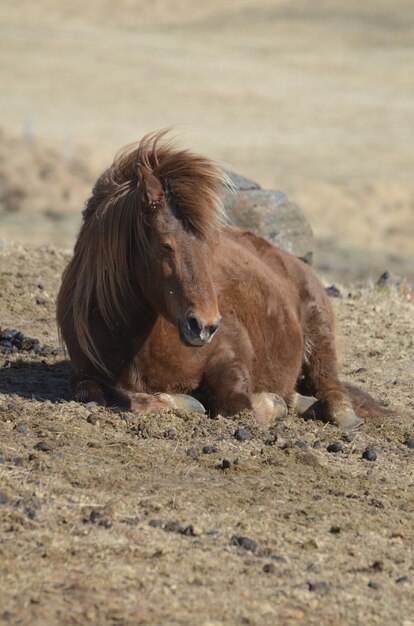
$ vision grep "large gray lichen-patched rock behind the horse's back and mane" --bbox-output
[224,172,314,263]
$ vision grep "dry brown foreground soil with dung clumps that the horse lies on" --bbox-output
[0,245,414,626]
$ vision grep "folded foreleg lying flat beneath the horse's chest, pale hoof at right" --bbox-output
[74,379,205,415]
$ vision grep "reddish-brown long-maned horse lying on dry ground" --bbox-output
[57,133,388,428]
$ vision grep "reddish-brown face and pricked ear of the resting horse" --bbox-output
[140,168,221,346]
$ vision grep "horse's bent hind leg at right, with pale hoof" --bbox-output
[295,294,363,430]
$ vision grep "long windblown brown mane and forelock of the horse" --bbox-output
[57,131,231,373]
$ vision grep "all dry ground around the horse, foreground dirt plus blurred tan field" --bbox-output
[0,0,414,626]
